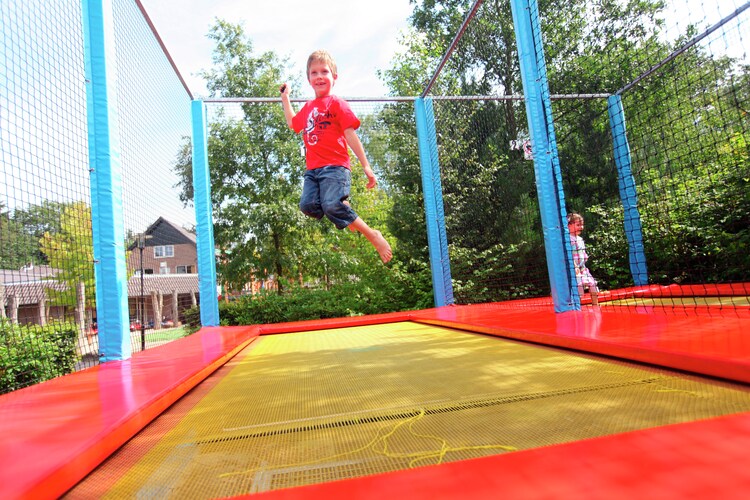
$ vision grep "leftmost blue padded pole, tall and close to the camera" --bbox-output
[81,0,131,362]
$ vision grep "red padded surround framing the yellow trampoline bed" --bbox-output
[0,294,750,499]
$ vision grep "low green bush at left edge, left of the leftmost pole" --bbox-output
[0,320,78,394]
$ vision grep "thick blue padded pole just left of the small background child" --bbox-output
[511,0,580,312]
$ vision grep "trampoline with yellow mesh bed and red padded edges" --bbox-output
[0,288,750,498]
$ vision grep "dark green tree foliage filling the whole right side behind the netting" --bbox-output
[383,0,748,301]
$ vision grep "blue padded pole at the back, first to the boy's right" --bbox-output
[414,97,454,307]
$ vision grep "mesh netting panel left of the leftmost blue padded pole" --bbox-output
[0,1,91,393]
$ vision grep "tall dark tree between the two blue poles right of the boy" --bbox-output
[384,1,560,300]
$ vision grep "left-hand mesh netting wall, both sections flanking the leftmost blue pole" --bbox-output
[0,0,198,393]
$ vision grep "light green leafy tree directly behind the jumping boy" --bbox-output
[170,20,432,308]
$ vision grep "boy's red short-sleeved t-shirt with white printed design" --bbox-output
[292,95,360,170]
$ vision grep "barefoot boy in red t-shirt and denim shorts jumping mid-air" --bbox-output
[280,50,392,263]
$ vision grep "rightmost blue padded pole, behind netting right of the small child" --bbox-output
[607,95,648,286]
